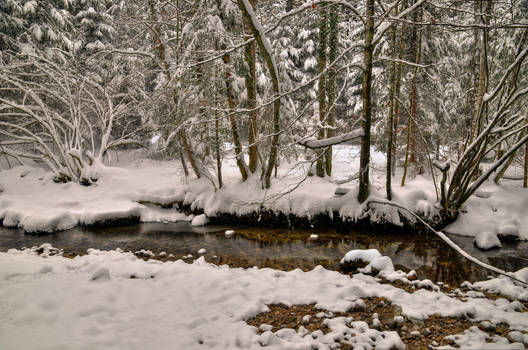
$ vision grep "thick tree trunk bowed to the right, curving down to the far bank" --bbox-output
[238,0,280,188]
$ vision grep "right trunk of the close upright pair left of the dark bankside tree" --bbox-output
[325,6,339,176]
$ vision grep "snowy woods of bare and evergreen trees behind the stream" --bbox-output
[0,0,528,222]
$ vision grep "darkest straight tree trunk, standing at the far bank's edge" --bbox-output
[358,0,374,203]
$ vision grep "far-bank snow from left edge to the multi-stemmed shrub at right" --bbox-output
[0,146,436,232]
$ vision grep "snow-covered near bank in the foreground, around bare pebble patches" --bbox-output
[0,245,528,350]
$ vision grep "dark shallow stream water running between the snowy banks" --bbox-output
[0,223,528,285]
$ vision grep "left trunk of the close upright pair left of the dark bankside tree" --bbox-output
[315,7,328,177]
